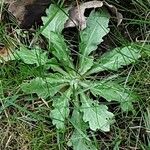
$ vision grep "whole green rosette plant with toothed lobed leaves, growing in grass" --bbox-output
[18,5,140,150]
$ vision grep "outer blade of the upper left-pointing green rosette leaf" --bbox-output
[15,47,48,66]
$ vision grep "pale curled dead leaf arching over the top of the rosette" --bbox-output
[65,1,123,30]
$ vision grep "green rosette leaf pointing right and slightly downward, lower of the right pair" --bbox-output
[90,81,138,111]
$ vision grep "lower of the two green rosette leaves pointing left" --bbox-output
[21,77,66,98]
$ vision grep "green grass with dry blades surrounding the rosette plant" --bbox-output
[0,0,150,150]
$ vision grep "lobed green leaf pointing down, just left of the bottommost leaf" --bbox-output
[51,89,71,129]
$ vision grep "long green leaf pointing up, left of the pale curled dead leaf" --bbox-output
[42,4,73,70]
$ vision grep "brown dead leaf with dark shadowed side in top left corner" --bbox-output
[8,0,51,28]
